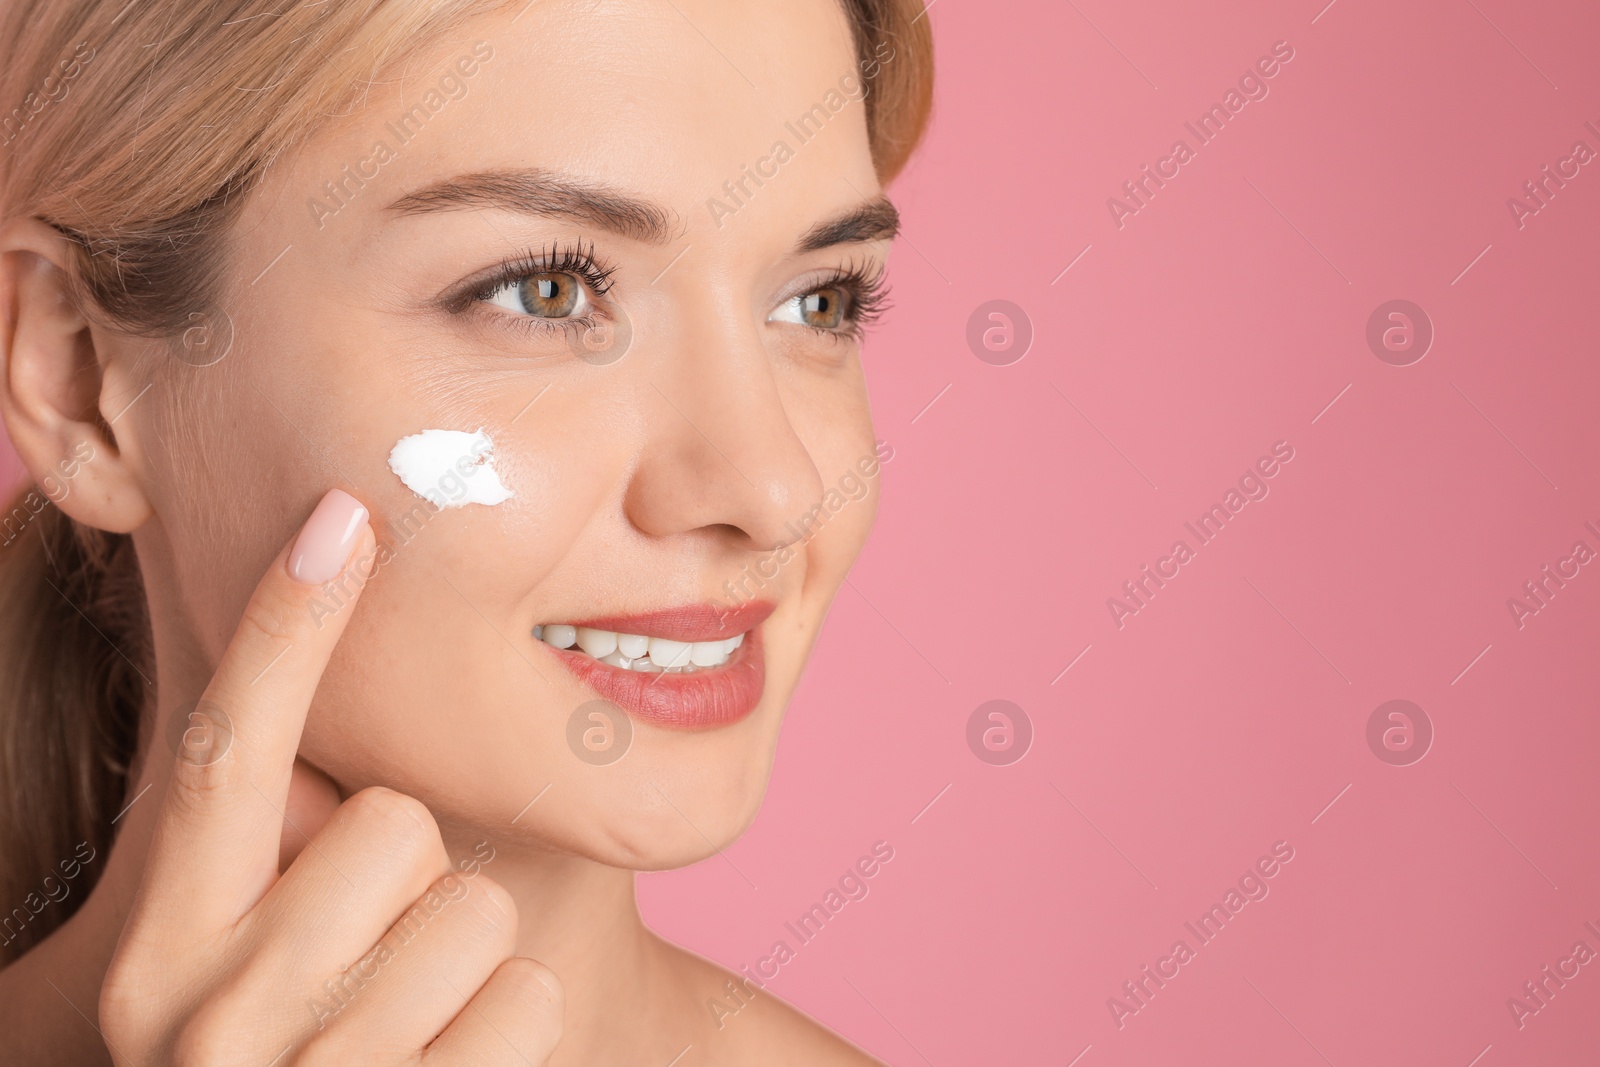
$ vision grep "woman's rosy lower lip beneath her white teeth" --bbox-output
[546,627,766,729]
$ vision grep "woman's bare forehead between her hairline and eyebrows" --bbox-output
[254,0,875,239]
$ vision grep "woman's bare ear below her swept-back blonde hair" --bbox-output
[0,219,152,533]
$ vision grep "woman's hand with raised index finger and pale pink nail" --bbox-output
[99,490,563,1067]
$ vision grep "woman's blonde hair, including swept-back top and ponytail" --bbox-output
[0,0,933,966]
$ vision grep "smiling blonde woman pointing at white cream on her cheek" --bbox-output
[0,0,931,1064]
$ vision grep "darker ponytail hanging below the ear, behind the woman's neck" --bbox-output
[0,486,154,966]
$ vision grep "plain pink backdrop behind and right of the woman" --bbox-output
[12,0,1600,1067]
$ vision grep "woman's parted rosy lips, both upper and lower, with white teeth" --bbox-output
[534,601,774,729]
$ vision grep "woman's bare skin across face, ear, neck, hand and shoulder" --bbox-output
[0,0,891,1065]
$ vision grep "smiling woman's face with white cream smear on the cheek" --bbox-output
[134,0,894,869]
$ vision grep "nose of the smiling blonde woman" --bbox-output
[626,309,822,550]
